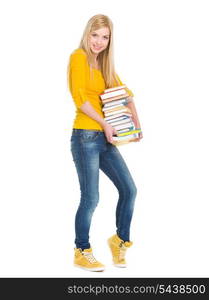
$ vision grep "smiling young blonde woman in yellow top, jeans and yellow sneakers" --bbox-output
[68,15,142,271]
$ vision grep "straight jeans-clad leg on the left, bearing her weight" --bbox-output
[71,131,99,250]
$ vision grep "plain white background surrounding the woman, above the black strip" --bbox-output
[0,0,209,277]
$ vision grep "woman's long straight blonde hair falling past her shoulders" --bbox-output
[79,14,120,88]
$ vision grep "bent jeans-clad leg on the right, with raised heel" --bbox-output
[100,144,137,241]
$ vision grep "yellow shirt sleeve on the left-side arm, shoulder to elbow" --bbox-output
[69,53,88,108]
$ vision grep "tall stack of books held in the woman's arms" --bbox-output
[100,85,140,146]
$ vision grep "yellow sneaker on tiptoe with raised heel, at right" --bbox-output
[107,234,133,268]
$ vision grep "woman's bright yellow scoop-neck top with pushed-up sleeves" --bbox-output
[69,48,133,131]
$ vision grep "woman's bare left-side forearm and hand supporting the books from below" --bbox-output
[80,101,117,143]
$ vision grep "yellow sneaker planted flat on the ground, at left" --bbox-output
[74,248,105,272]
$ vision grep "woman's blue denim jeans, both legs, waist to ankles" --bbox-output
[71,128,137,250]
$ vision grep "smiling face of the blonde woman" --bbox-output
[89,27,110,55]
